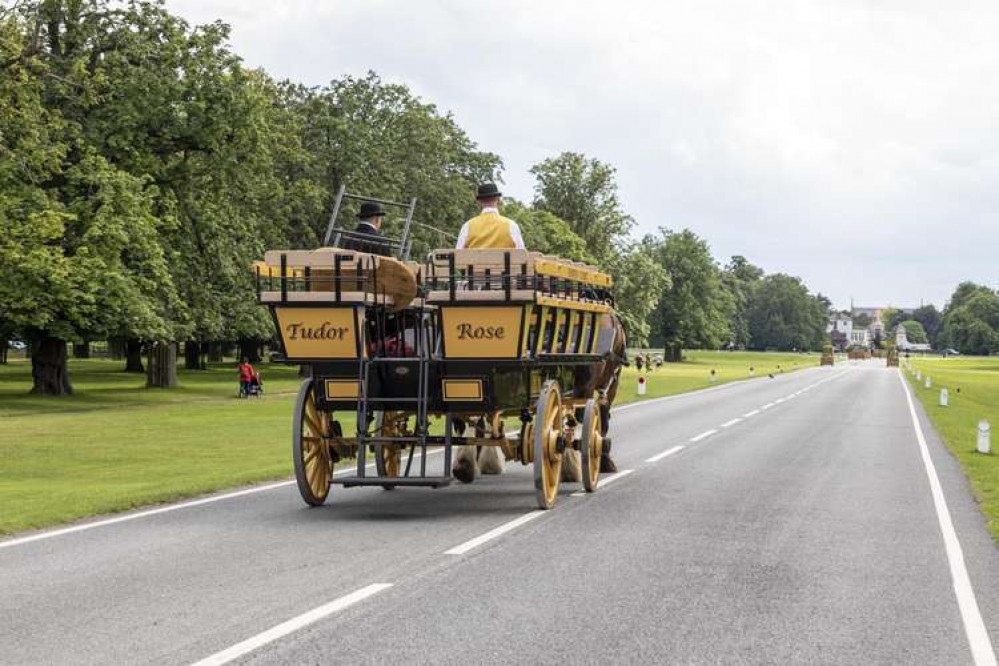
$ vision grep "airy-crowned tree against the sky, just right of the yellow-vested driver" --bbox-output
[531,152,634,261]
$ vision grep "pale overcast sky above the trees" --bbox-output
[167,0,999,307]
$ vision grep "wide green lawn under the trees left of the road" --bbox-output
[0,352,818,534]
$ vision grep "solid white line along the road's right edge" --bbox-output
[898,372,996,666]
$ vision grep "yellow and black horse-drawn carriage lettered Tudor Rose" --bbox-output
[254,195,625,509]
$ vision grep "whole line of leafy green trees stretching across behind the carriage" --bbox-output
[0,0,999,395]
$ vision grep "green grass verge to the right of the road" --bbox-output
[904,358,999,541]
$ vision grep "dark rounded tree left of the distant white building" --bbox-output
[746,273,829,351]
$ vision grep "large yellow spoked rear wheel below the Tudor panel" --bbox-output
[292,378,333,506]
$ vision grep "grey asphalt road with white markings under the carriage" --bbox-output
[0,362,999,665]
